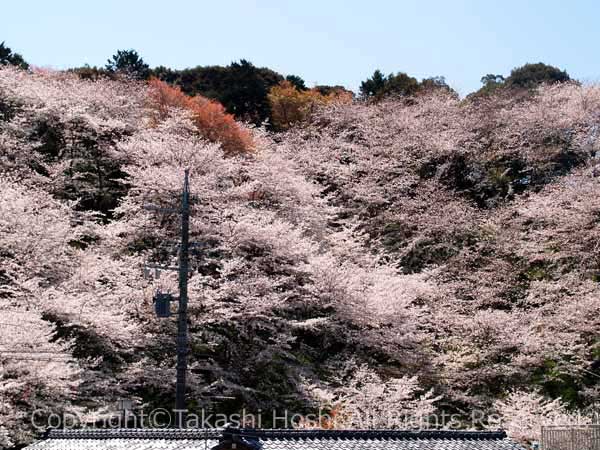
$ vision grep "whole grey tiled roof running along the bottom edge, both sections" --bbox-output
[27,428,523,450]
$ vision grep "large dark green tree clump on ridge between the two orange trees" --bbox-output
[153,59,282,124]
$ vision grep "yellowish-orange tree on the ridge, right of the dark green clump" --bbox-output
[268,80,352,130]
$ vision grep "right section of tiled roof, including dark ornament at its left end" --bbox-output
[218,429,523,450]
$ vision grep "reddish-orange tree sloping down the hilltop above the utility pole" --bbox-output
[149,78,253,155]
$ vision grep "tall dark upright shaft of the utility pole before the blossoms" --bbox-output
[175,169,190,428]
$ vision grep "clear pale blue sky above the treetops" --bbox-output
[0,0,600,95]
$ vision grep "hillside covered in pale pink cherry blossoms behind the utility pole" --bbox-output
[0,67,600,446]
